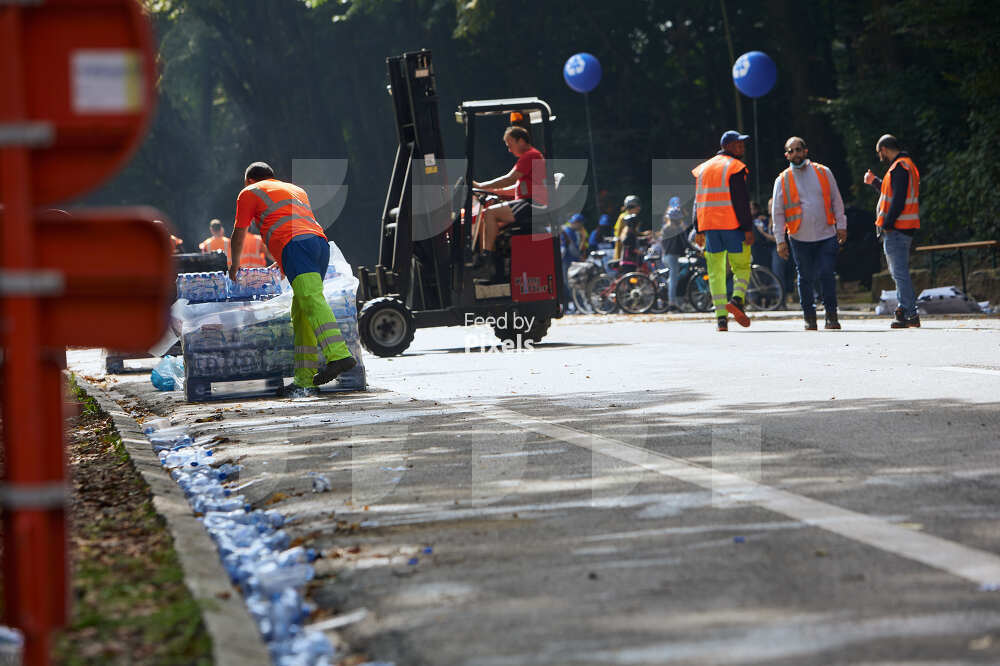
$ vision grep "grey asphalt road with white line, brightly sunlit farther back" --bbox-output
[75,317,1000,666]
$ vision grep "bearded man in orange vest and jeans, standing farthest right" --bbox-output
[865,134,920,328]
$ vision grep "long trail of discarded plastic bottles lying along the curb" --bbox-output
[143,419,336,666]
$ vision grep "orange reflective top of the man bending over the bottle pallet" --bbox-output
[236,178,326,266]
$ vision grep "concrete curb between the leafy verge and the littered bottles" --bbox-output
[76,375,271,666]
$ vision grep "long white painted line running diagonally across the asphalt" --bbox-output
[470,402,1000,586]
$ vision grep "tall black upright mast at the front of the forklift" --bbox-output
[374,50,457,310]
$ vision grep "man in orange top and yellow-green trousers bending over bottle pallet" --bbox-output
[229,162,357,397]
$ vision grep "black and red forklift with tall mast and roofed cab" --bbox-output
[356,50,563,356]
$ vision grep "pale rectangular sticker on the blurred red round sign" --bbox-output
[70,49,145,113]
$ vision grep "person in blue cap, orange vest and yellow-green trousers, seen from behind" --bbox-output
[691,130,753,331]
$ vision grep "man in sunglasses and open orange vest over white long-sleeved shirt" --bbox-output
[771,136,847,331]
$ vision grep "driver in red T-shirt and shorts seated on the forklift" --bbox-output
[472,125,549,274]
